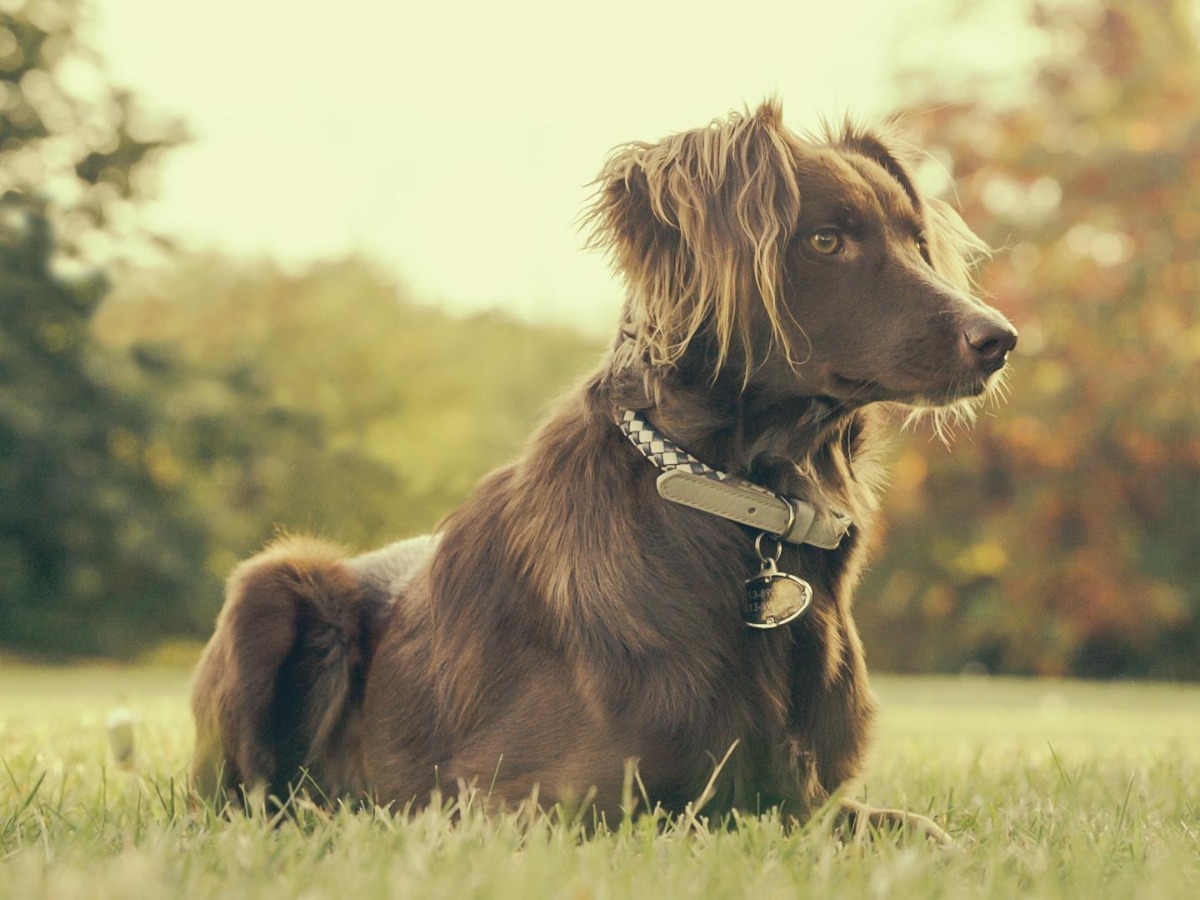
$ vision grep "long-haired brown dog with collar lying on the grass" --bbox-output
[192,101,1016,839]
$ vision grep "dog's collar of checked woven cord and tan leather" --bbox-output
[618,409,851,550]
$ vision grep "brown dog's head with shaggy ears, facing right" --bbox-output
[589,102,1016,415]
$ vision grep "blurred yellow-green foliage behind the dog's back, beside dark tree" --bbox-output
[96,257,598,564]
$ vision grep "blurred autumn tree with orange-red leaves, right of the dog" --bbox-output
[864,0,1200,678]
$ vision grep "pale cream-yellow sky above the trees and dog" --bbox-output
[91,0,1036,330]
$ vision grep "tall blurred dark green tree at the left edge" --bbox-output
[0,0,211,654]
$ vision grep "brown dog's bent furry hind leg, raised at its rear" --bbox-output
[192,538,390,805]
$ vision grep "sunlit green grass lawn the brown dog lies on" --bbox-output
[0,666,1200,900]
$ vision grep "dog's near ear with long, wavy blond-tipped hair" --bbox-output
[588,102,800,371]
